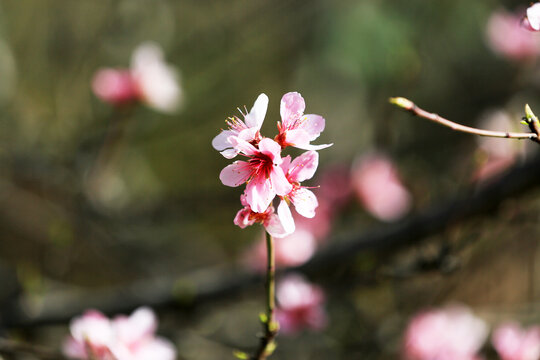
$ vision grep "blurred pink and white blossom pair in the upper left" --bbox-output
[92,43,182,113]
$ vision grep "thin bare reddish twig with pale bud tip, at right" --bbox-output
[390,97,539,142]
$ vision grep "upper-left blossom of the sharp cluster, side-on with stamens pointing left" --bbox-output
[212,94,268,159]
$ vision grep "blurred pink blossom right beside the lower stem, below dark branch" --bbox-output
[276,275,328,334]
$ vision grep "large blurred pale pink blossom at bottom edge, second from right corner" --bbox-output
[403,307,489,360]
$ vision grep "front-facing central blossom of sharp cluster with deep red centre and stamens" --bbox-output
[219,136,292,213]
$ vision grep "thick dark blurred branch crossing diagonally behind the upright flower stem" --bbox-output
[1,156,540,327]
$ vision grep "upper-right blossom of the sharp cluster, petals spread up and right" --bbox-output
[276,92,332,150]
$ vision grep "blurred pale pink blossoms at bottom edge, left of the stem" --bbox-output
[63,307,176,360]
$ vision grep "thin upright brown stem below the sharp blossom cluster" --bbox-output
[251,233,279,360]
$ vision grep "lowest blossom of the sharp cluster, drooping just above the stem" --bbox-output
[233,194,294,238]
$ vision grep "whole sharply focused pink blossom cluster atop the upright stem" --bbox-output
[212,92,332,238]
